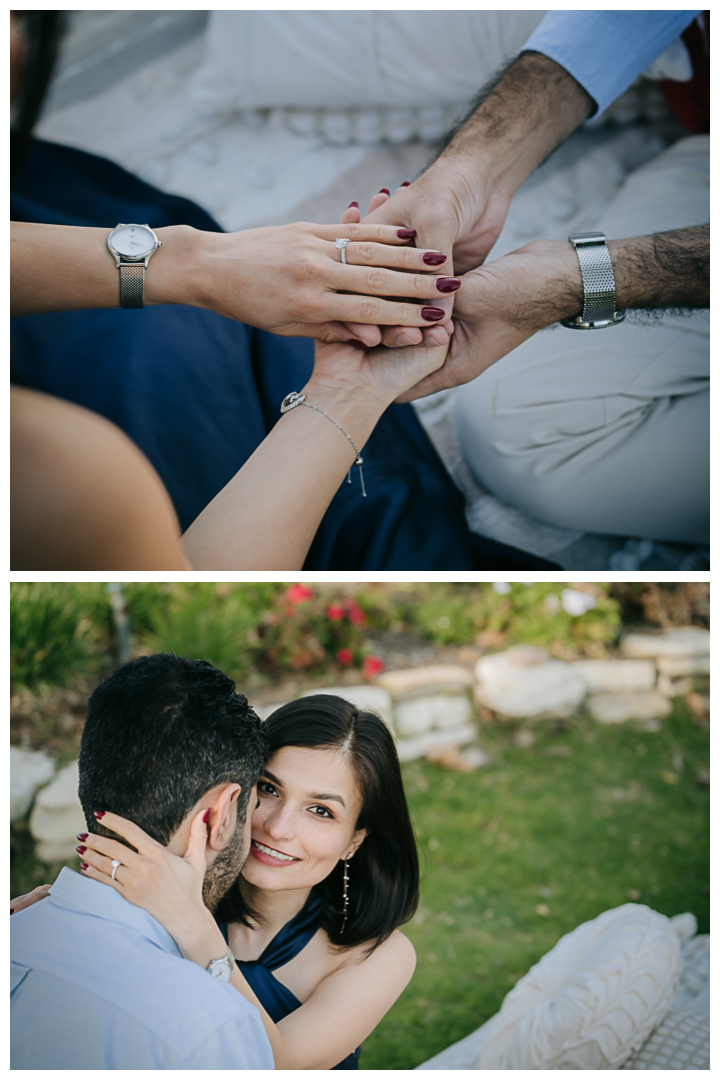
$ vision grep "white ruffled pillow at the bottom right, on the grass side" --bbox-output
[476,904,681,1069]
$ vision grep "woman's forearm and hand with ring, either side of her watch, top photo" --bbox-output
[11,221,449,346]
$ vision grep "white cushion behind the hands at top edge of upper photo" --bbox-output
[188,11,545,111]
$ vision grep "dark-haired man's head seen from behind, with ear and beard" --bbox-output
[79,653,266,908]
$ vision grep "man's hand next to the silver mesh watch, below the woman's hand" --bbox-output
[397,240,583,402]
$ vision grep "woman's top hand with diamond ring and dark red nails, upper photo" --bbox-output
[185,222,457,347]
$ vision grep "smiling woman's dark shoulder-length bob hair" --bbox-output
[216,693,419,955]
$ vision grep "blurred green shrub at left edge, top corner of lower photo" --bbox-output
[10,582,97,689]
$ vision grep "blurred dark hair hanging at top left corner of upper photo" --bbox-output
[10,11,67,174]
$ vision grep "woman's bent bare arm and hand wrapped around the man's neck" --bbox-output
[78,810,416,1069]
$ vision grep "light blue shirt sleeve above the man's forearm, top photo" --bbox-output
[520,10,701,116]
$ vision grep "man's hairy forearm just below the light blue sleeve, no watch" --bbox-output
[427,53,595,190]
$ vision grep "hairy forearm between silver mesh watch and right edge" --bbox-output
[608,225,710,311]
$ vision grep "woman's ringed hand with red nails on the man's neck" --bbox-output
[77,810,221,959]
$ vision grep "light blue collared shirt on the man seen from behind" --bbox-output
[10,867,273,1069]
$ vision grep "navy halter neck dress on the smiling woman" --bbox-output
[219,893,361,1069]
